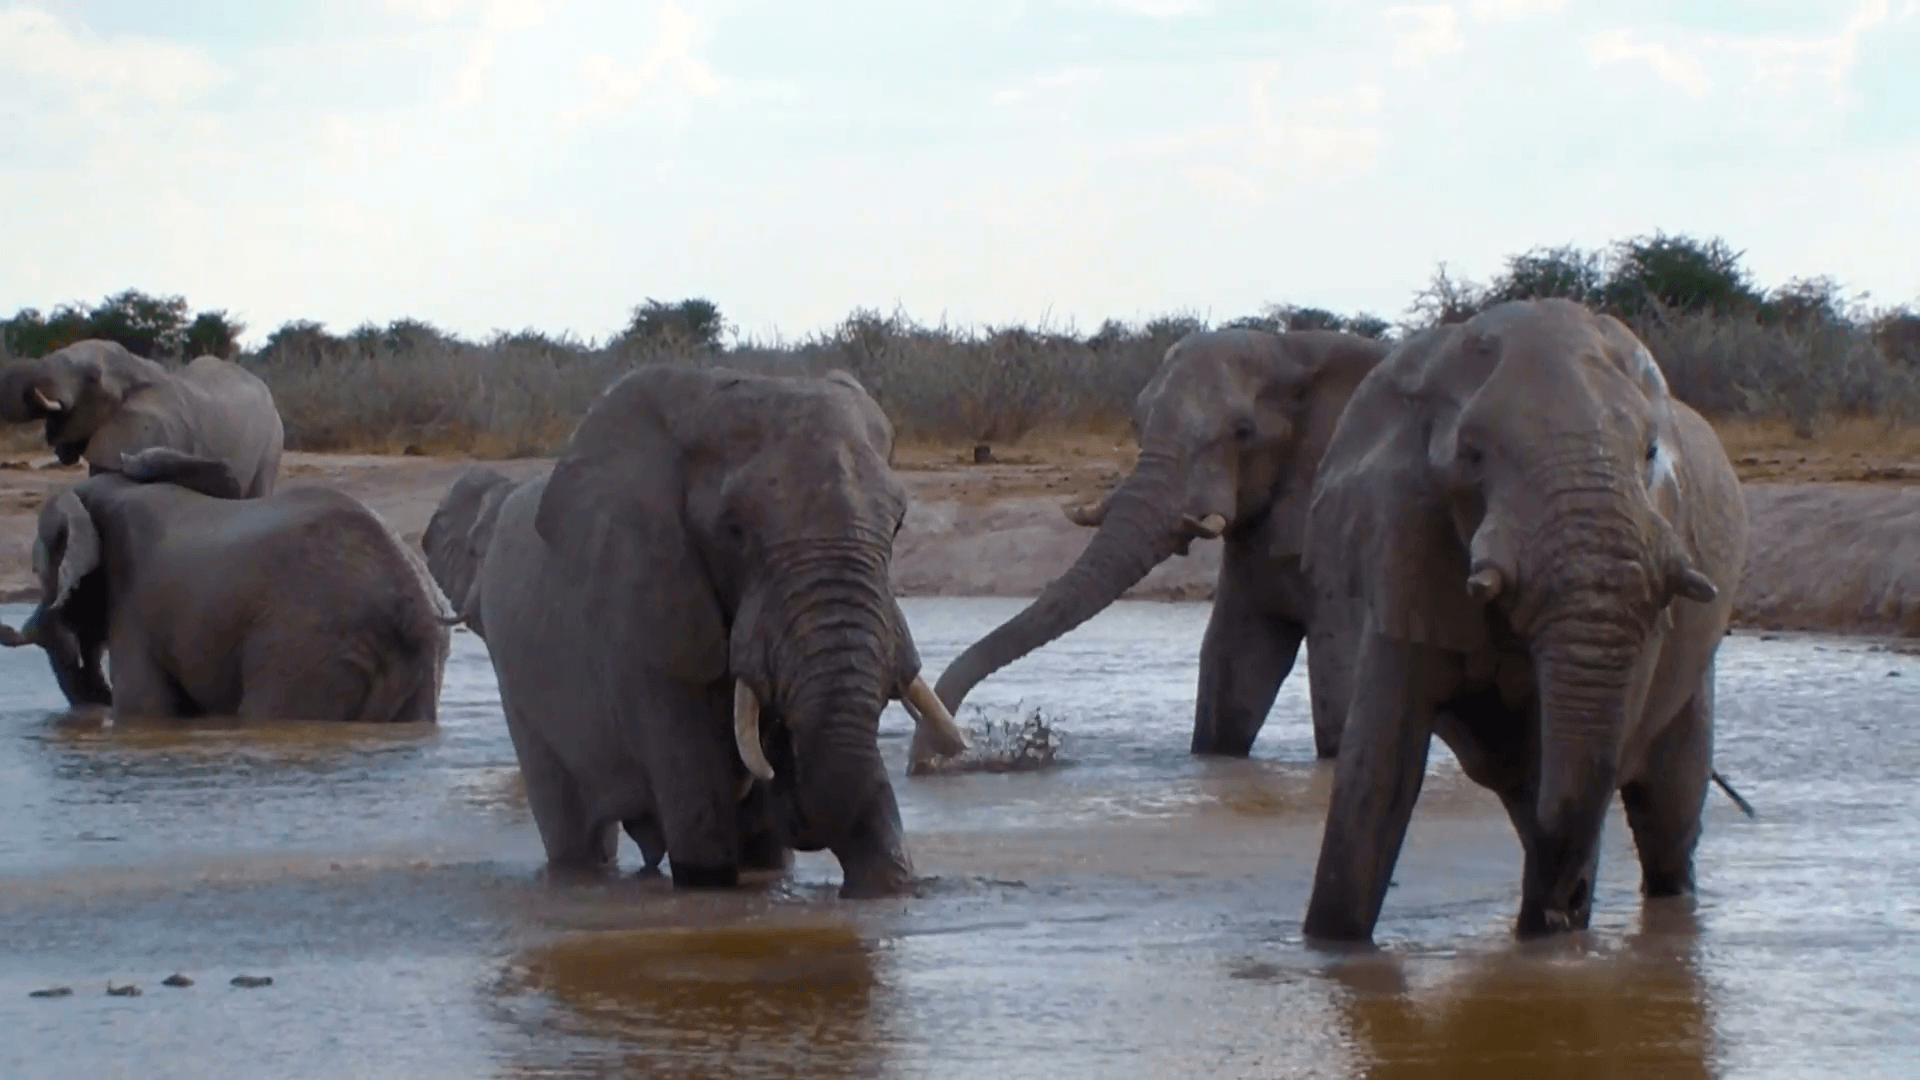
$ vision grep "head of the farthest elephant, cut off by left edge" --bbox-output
[0,338,167,465]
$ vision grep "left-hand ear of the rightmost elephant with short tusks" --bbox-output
[1302,325,1486,651]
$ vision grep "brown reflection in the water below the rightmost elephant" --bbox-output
[1332,901,1716,1080]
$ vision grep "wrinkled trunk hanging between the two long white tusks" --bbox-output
[768,542,895,851]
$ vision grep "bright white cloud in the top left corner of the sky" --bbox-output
[0,8,225,108]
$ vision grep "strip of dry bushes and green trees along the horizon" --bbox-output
[0,233,1920,455]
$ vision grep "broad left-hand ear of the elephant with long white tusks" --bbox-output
[534,365,728,684]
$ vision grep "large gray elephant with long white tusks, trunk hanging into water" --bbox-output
[422,365,966,897]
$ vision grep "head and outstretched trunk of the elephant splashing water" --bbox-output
[937,329,1386,709]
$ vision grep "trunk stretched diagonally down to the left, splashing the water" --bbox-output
[935,454,1187,711]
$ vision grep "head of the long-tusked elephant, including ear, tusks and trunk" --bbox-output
[534,365,966,864]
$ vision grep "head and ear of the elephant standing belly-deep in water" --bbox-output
[0,446,240,705]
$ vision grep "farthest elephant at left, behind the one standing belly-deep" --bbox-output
[0,338,286,498]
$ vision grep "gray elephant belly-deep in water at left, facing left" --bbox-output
[0,446,451,723]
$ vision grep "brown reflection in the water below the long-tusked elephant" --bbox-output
[495,919,887,1078]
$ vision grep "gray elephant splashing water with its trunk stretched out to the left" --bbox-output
[935,329,1388,757]
